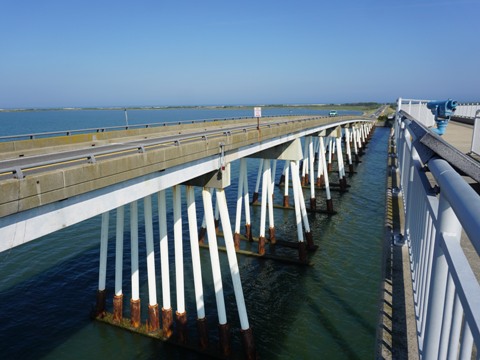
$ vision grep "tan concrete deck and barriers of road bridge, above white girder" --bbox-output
[0,116,367,217]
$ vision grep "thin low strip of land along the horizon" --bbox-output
[0,102,381,112]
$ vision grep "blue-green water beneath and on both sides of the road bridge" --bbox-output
[0,110,388,359]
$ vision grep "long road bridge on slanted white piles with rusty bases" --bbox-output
[0,112,375,358]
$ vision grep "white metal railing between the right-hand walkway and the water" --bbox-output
[394,104,480,359]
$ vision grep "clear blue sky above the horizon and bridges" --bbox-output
[0,0,480,108]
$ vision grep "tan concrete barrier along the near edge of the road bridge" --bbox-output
[0,117,366,217]
